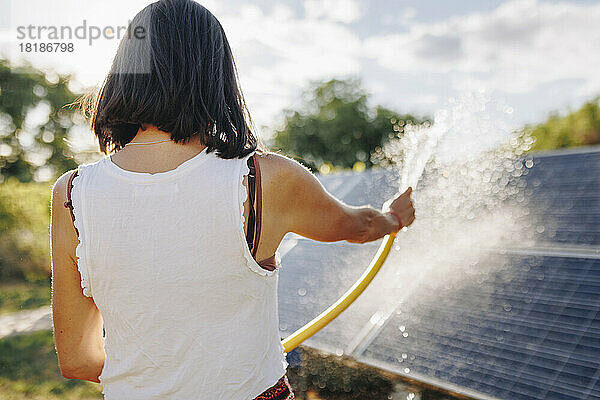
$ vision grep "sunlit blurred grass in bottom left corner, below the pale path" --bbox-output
[0,331,102,400]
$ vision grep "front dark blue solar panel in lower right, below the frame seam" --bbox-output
[364,255,600,399]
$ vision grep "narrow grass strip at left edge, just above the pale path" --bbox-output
[0,281,51,315]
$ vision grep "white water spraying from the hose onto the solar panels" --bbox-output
[344,92,533,360]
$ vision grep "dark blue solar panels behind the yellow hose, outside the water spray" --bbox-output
[279,149,600,400]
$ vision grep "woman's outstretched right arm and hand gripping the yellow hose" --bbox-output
[271,153,414,243]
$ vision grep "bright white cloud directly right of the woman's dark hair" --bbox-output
[218,5,362,138]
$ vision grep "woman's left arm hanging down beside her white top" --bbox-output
[50,171,105,383]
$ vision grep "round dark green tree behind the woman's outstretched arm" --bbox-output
[273,79,427,171]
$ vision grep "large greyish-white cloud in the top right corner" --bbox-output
[364,0,600,93]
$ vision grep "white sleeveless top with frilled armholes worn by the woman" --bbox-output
[71,149,288,400]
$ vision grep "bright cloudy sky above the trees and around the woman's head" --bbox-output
[0,0,600,142]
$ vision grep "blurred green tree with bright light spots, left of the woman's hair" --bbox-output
[0,59,84,182]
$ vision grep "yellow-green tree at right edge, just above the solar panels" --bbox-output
[525,97,600,150]
